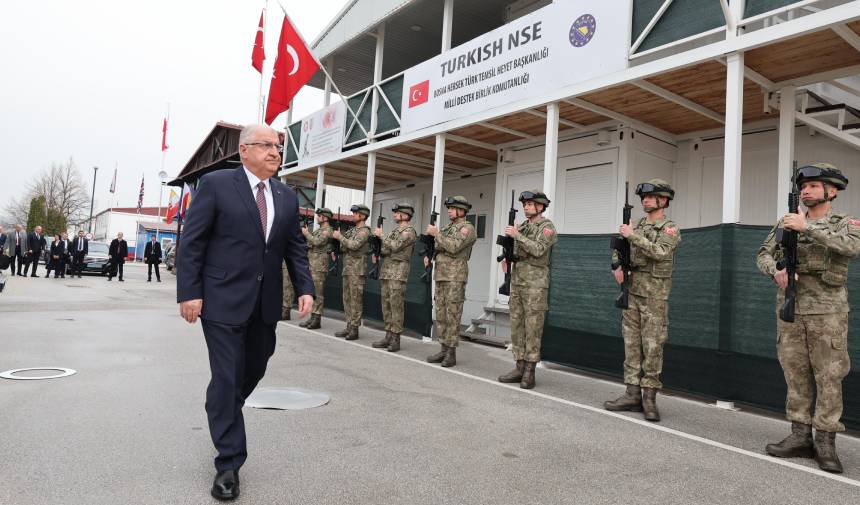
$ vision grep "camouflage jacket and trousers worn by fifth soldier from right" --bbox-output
[379,223,418,334]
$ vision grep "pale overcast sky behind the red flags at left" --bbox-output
[0,0,347,222]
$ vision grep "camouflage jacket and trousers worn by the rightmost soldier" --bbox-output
[757,212,860,432]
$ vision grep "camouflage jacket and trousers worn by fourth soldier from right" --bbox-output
[434,218,477,347]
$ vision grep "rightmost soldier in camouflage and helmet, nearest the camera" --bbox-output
[757,163,860,473]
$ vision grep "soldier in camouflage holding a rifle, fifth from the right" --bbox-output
[372,203,418,352]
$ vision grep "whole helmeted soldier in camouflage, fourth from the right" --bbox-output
[424,196,478,367]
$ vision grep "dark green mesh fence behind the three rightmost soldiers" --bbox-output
[543,225,860,428]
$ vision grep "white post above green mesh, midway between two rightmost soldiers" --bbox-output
[721,53,744,223]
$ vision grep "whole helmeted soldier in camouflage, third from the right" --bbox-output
[499,190,558,389]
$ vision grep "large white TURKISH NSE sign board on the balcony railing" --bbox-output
[401,0,631,133]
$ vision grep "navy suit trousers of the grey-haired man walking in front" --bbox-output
[201,294,275,472]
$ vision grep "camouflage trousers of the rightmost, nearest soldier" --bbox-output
[776,312,851,432]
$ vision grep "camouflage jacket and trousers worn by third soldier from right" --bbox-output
[508,217,558,363]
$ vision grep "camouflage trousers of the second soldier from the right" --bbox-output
[621,293,669,389]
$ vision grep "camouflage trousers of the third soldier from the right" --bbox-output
[508,286,548,363]
